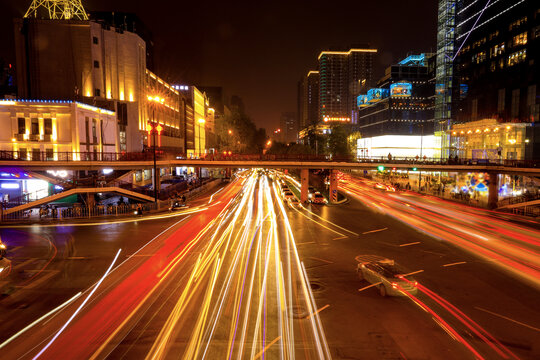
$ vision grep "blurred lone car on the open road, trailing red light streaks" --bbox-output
[356,259,418,296]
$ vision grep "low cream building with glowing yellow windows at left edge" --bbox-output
[0,100,119,160]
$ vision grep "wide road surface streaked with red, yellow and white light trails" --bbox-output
[0,172,540,359]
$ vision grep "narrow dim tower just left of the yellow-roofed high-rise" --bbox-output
[298,70,319,130]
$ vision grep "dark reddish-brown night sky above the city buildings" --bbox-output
[0,0,437,132]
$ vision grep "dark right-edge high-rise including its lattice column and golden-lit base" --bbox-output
[435,0,540,159]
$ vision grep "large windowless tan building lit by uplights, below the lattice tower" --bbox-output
[15,8,146,151]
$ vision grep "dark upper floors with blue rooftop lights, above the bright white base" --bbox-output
[354,54,434,145]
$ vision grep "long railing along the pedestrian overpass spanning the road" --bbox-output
[0,150,540,168]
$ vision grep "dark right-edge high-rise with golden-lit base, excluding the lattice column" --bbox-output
[447,0,540,159]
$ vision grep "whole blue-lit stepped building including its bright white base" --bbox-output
[354,53,440,157]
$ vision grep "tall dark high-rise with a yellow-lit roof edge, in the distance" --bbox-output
[319,48,377,123]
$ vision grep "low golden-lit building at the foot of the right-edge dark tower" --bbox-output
[448,119,534,160]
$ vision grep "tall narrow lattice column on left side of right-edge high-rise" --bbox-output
[435,0,457,157]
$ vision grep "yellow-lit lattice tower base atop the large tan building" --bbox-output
[24,0,88,20]
